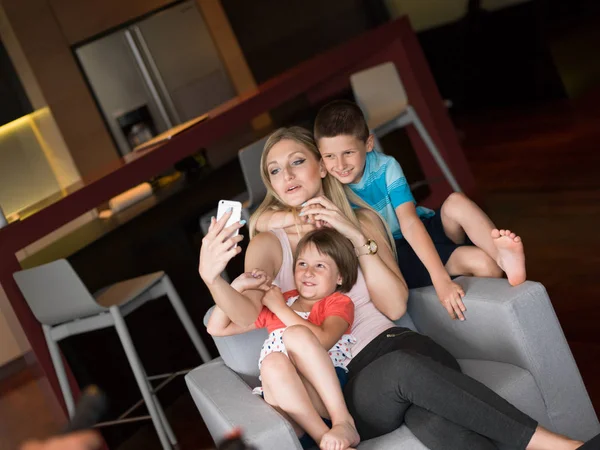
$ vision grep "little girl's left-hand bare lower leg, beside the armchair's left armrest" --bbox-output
[260,353,329,442]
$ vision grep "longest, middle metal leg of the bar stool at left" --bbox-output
[110,306,172,450]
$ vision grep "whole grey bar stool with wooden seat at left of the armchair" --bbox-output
[13,259,212,449]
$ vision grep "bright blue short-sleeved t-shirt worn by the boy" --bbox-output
[348,150,435,239]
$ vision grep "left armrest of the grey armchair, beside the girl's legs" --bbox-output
[185,358,302,450]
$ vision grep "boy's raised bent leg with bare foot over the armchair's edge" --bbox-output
[440,192,526,285]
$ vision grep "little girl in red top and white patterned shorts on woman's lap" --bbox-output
[207,228,360,450]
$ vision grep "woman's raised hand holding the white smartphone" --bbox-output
[198,211,246,285]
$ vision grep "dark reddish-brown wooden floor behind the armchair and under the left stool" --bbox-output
[0,93,600,450]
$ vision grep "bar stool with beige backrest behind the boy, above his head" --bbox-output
[350,62,461,192]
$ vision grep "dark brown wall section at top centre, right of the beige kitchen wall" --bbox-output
[222,0,389,83]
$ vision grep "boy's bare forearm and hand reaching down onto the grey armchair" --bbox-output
[396,202,466,320]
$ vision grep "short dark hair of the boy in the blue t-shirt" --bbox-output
[314,100,369,142]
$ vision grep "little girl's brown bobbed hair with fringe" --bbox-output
[294,228,358,293]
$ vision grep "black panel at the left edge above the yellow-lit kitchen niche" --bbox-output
[0,41,32,126]
